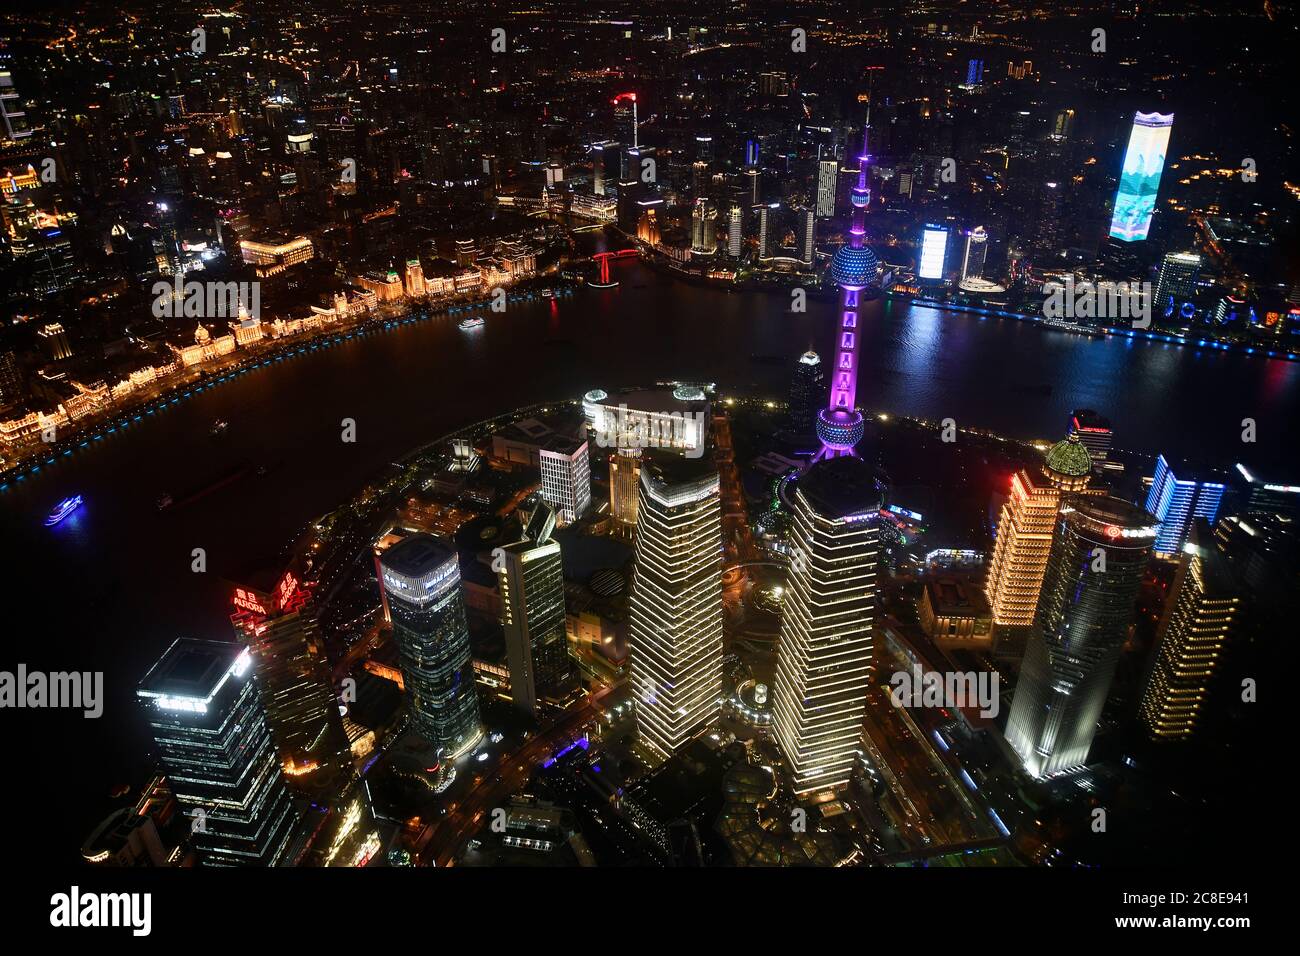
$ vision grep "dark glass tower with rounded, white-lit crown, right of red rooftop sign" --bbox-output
[380,535,482,758]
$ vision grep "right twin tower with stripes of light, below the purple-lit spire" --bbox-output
[774,457,881,795]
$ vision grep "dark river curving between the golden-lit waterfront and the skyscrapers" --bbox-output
[0,261,1300,857]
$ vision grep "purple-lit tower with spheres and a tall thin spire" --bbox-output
[814,100,880,460]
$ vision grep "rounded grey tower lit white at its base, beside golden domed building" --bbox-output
[1006,496,1158,778]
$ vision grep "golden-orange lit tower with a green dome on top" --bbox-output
[984,434,1092,628]
